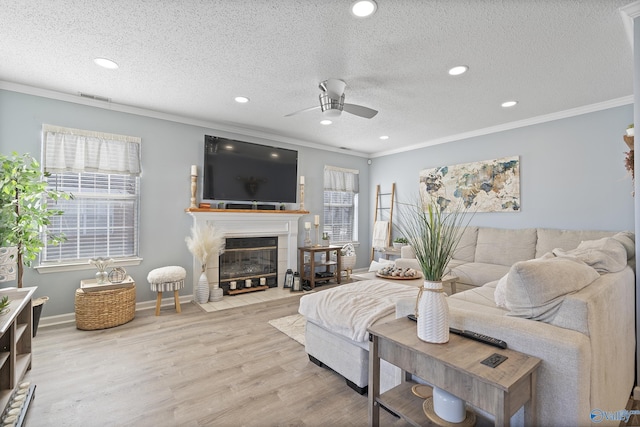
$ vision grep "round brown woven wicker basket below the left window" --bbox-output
[75,285,136,331]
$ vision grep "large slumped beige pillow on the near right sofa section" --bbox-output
[506,254,600,321]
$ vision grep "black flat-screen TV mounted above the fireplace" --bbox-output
[202,135,298,203]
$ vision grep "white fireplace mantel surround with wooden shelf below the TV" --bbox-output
[187,209,309,295]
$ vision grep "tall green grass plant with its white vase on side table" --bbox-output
[398,196,468,343]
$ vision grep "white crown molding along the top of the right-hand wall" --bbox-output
[371,95,633,158]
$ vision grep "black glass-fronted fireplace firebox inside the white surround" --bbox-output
[218,236,278,295]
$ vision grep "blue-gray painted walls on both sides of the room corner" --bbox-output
[0,90,634,317]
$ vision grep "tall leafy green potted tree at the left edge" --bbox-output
[0,153,71,336]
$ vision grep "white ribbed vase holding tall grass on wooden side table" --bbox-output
[417,280,449,344]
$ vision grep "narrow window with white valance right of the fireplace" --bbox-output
[323,166,359,244]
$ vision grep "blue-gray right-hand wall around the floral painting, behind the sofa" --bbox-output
[370,105,634,237]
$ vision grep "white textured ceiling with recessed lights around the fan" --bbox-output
[0,0,633,154]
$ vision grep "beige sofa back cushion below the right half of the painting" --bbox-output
[474,227,536,266]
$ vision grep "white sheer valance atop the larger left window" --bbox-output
[42,125,141,176]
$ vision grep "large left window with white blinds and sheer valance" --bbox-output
[40,125,140,266]
